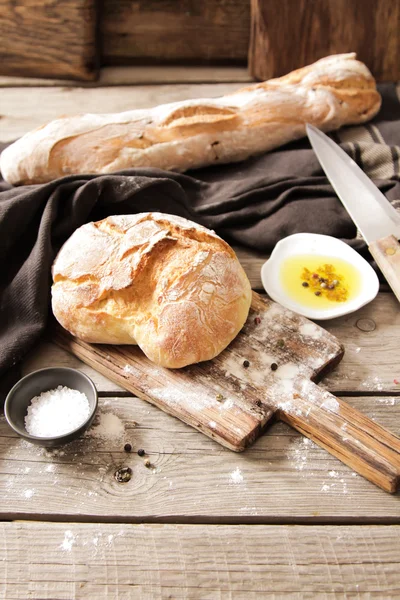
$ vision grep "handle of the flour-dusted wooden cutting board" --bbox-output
[279,380,400,493]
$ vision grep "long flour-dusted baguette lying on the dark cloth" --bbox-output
[0,53,381,185]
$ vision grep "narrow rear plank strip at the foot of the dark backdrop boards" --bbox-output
[0,65,253,88]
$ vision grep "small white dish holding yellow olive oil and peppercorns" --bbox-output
[261,233,379,320]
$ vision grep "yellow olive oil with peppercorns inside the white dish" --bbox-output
[281,254,361,309]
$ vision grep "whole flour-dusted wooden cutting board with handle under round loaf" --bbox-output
[54,292,400,492]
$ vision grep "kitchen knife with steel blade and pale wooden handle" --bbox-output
[306,125,400,302]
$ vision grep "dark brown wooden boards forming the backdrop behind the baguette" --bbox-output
[0,0,400,81]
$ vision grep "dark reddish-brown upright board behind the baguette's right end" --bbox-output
[249,0,400,81]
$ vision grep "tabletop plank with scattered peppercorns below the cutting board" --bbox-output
[0,396,400,523]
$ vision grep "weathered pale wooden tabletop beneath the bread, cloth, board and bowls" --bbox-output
[0,69,400,600]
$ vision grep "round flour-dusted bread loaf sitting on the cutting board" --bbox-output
[52,213,251,368]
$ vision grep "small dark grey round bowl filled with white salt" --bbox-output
[4,367,98,448]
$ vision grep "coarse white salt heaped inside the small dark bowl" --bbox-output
[25,385,90,437]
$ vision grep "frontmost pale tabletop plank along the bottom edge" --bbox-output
[0,523,400,600]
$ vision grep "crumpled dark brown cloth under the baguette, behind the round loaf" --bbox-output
[0,84,400,390]
